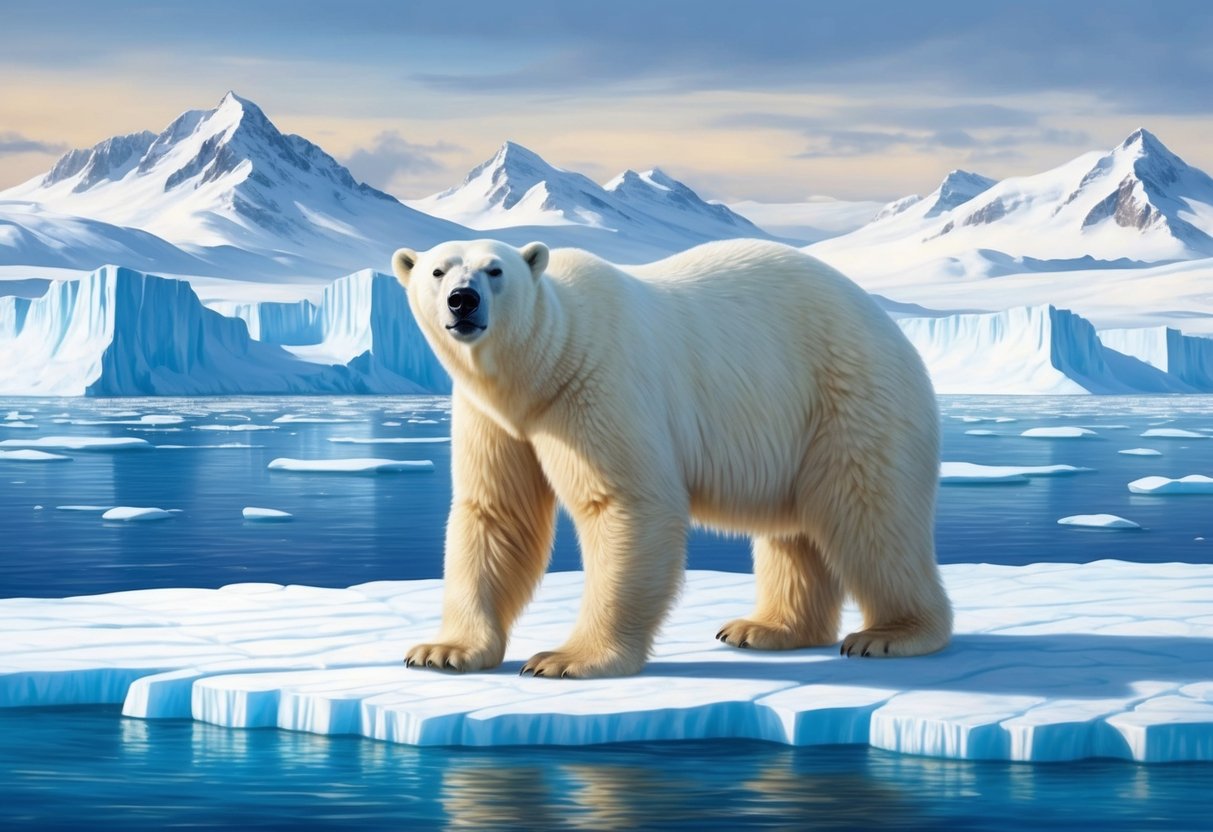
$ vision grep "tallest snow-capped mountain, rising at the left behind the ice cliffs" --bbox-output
[0,92,469,277]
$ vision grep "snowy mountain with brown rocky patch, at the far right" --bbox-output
[809,130,1213,287]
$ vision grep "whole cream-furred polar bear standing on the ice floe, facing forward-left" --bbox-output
[392,240,951,677]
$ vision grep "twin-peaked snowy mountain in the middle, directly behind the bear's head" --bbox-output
[409,142,770,253]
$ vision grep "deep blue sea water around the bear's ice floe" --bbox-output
[0,397,1213,830]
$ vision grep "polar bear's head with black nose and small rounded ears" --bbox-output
[392,240,548,346]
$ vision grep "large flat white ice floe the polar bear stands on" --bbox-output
[0,560,1213,762]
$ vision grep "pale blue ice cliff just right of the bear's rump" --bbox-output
[896,306,1198,395]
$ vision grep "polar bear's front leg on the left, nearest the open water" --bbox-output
[405,394,556,671]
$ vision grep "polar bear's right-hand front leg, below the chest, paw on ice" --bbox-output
[522,497,687,678]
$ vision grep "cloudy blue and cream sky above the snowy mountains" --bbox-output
[0,0,1213,201]
